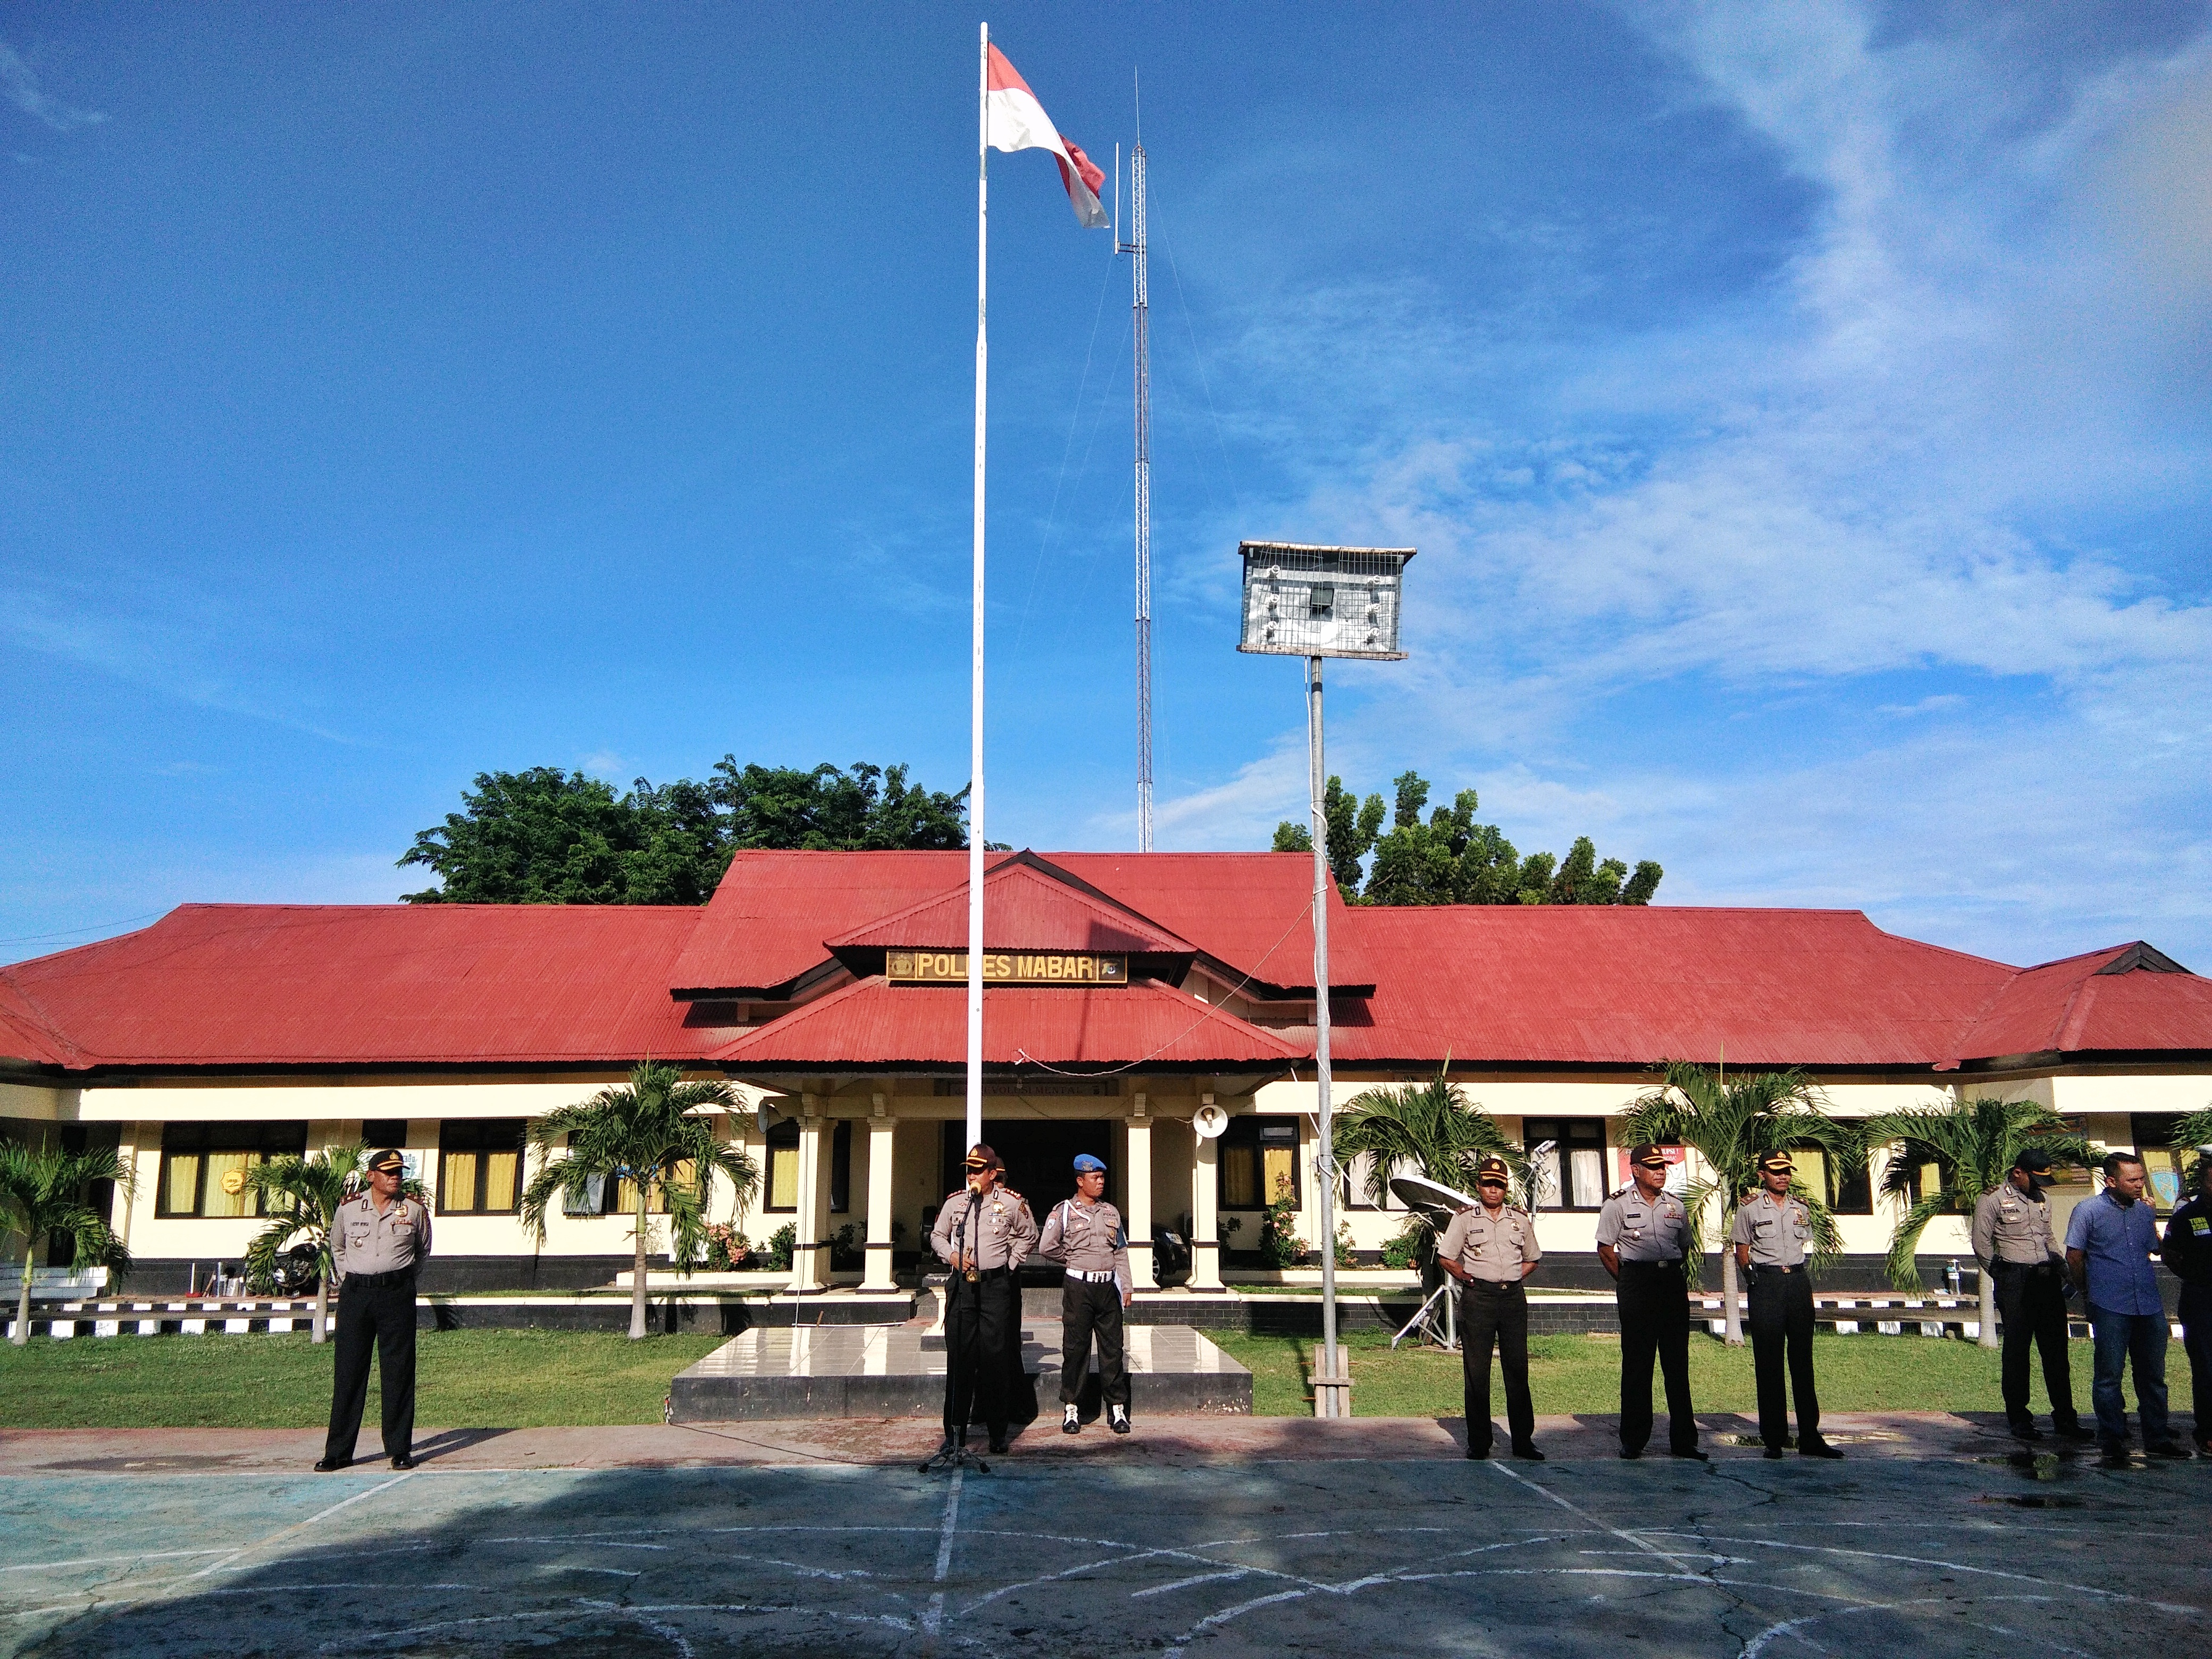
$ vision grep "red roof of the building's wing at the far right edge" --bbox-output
[1953,940,2212,1060]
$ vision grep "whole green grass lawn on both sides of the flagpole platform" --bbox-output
[0,1331,2190,1429]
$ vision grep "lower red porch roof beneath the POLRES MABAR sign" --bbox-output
[715,978,1310,1070]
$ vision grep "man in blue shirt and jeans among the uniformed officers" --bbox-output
[2066,1152,2190,1457]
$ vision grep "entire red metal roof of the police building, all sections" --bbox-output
[0,852,2212,1068]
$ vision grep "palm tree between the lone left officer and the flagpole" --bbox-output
[522,1060,759,1338]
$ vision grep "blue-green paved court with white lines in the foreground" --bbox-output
[0,1455,2212,1659]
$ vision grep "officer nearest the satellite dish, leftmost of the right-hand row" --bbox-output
[1436,1157,1544,1462]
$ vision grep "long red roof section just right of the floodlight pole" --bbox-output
[1331,904,2026,1066]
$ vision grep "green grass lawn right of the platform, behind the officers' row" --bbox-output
[1208,1331,2190,1418]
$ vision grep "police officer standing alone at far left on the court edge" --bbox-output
[316,1148,429,1473]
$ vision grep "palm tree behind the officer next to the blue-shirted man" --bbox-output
[1865,1095,2097,1347]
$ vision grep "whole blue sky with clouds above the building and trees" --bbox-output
[0,2,2212,971]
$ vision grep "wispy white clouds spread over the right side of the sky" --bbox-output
[1179,2,2212,958]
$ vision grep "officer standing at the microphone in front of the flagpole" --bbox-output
[929,1142,1037,1451]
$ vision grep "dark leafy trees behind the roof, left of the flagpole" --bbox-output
[400,755,967,904]
